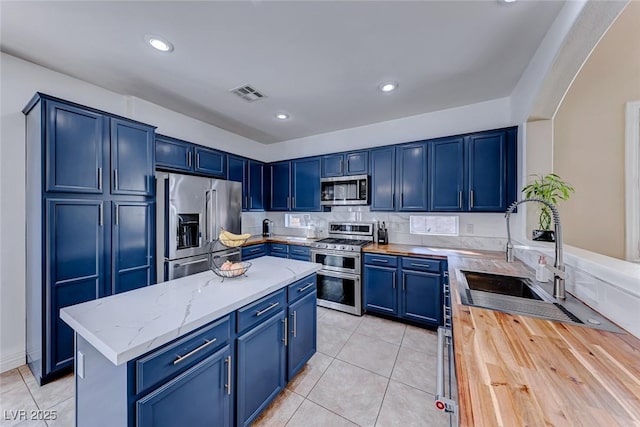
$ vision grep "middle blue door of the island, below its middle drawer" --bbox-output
[236,310,287,426]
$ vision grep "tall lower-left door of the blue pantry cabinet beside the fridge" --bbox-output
[46,199,108,376]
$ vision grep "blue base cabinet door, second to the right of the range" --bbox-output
[400,270,442,325]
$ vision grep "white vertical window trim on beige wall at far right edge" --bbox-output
[625,101,640,262]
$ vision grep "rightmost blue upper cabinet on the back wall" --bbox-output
[466,128,515,212]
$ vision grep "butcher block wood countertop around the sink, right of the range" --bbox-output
[364,244,640,427]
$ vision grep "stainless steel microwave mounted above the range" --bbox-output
[320,175,369,206]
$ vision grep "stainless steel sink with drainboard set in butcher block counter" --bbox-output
[456,270,622,332]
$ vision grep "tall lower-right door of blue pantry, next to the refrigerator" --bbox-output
[111,201,156,294]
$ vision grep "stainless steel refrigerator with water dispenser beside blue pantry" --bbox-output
[156,173,242,280]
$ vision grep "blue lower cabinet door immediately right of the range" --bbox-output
[364,265,398,314]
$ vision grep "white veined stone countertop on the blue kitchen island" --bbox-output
[60,256,321,365]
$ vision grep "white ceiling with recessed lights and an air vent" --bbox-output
[0,0,564,143]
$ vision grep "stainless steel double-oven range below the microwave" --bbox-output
[311,222,374,316]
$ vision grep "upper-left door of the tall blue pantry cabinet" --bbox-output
[45,101,109,194]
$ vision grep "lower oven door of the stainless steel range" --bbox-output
[317,270,362,316]
